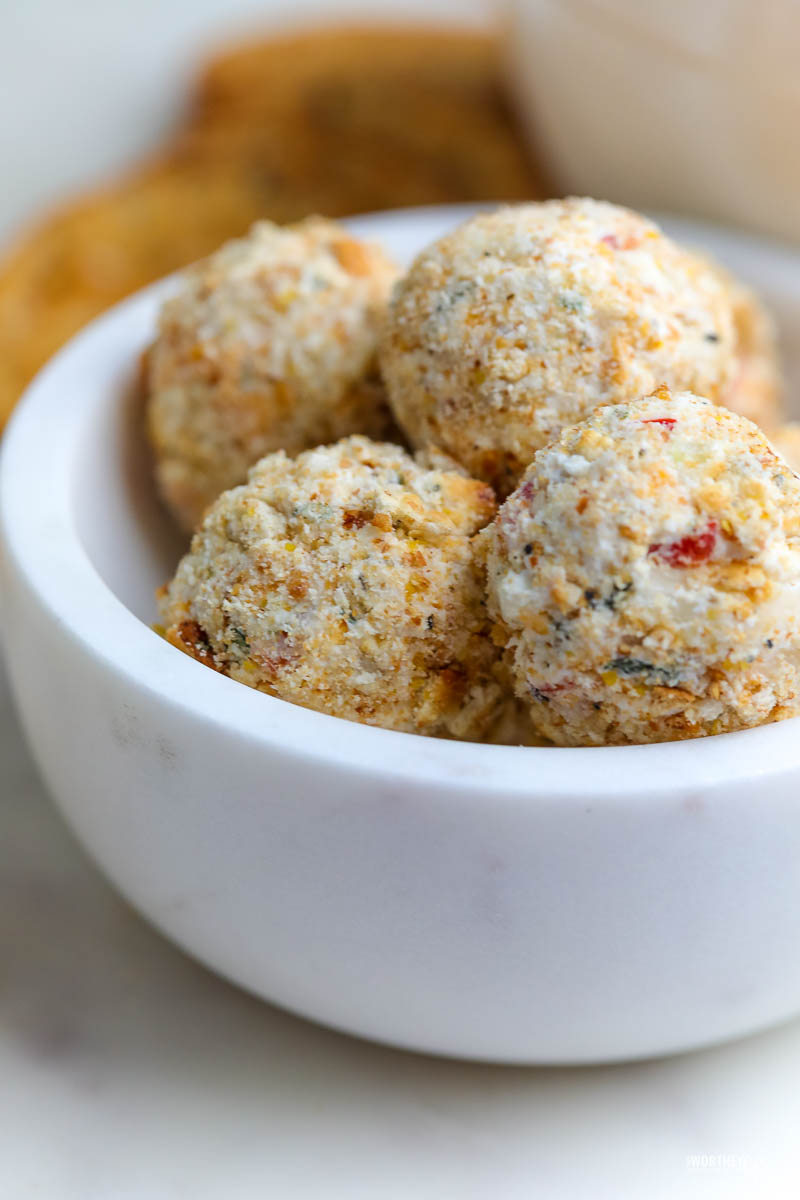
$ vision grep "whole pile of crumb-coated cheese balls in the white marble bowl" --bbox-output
[146,199,800,745]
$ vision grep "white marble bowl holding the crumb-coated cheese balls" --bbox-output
[0,209,800,1063]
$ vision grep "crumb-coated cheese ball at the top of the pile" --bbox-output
[380,199,735,496]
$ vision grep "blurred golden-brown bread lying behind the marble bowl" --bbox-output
[0,28,545,425]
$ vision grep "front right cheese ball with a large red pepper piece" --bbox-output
[483,388,800,745]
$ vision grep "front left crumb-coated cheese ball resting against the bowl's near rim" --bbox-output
[160,437,505,739]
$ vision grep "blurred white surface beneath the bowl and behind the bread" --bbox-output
[0,0,800,1200]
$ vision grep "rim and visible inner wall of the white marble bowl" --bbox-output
[0,206,800,803]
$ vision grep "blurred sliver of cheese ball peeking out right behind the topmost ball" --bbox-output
[716,266,783,434]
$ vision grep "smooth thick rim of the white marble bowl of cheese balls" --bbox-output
[0,205,800,803]
